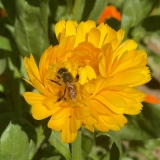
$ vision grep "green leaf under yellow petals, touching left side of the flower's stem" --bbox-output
[49,130,71,160]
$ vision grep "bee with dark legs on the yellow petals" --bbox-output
[51,68,79,102]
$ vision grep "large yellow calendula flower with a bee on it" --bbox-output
[24,20,151,143]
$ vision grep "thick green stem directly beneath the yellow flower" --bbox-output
[71,130,81,160]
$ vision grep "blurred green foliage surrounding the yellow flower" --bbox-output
[0,0,160,160]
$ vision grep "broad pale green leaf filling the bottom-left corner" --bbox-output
[0,123,29,160]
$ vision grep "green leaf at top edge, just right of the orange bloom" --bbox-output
[121,0,141,32]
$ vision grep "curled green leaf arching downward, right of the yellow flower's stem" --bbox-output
[97,131,122,160]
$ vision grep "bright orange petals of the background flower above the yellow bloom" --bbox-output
[98,6,121,24]
